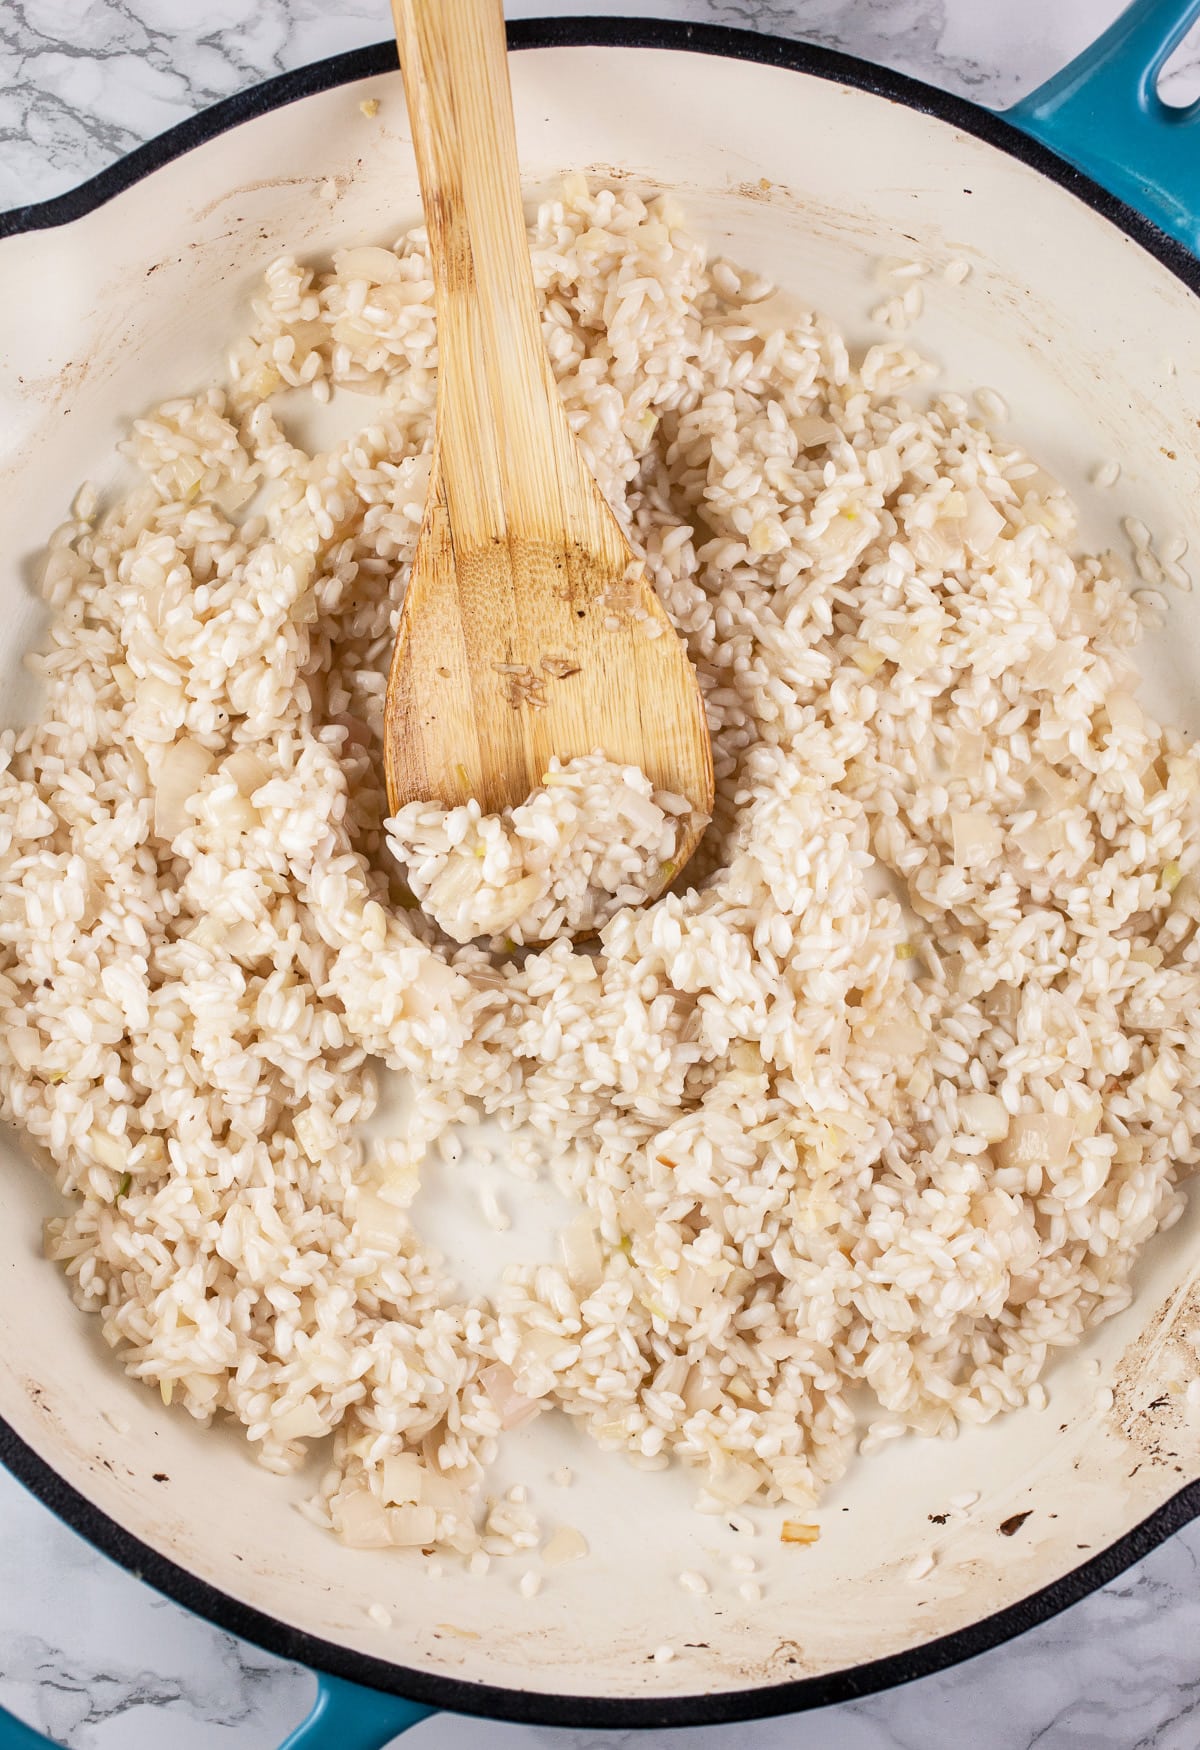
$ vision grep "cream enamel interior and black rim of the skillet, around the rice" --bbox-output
[0,10,1200,1747]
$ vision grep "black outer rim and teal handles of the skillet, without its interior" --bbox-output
[0,0,1200,1750]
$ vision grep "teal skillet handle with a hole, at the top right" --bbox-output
[1004,0,1200,256]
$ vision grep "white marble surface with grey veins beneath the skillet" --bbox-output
[0,0,1200,1750]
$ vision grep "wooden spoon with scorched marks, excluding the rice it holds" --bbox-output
[385,0,712,884]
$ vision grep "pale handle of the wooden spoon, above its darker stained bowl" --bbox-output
[392,0,584,546]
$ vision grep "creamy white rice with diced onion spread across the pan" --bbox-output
[0,184,1200,1565]
